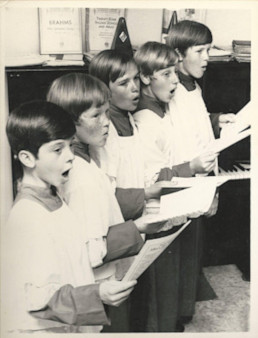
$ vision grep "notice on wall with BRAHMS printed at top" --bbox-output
[39,8,82,54]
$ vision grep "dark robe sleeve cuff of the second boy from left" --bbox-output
[103,221,143,263]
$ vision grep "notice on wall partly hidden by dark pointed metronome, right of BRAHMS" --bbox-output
[85,8,126,53]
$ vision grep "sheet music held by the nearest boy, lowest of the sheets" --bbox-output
[123,220,191,281]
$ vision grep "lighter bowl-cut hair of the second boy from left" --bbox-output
[47,73,111,122]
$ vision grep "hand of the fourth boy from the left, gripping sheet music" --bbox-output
[190,152,218,175]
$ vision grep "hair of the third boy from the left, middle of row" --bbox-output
[89,49,137,86]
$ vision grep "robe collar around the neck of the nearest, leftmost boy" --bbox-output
[14,183,63,211]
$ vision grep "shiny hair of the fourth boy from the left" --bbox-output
[134,41,178,76]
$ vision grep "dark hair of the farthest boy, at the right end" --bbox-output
[166,20,212,55]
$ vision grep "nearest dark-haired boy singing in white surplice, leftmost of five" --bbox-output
[2,101,135,333]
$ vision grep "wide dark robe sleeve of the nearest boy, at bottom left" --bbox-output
[30,284,110,326]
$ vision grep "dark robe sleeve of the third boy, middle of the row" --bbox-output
[116,188,144,221]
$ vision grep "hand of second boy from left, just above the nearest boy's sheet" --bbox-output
[134,214,169,234]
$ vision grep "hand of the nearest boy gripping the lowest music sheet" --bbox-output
[99,280,137,306]
